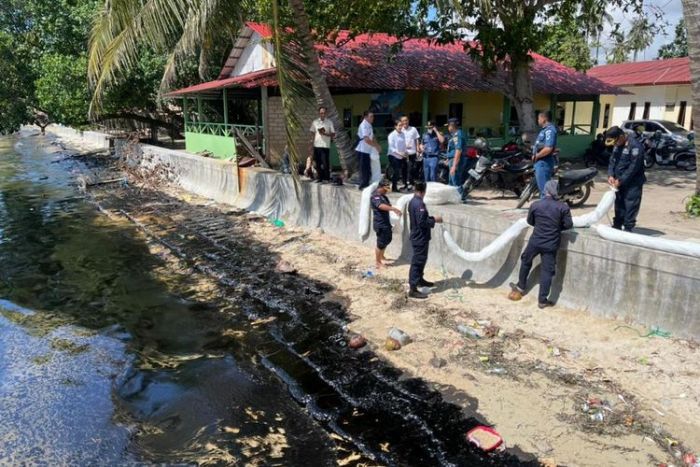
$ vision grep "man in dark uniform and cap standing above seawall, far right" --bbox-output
[605,126,647,232]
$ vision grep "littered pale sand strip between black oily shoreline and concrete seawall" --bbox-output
[231,213,700,466]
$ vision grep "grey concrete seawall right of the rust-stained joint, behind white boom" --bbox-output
[235,169,700,339]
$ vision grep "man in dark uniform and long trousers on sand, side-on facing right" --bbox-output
[408,182,442,298]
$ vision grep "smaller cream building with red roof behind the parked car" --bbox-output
[588,57,693,130]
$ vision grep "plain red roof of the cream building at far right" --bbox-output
[588,57,690,86]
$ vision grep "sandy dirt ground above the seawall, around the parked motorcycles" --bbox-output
[462,166,700,241]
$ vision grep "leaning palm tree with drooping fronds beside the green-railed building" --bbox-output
[88,0,354,182]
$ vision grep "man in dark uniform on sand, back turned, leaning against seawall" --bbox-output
[508,180,574,308]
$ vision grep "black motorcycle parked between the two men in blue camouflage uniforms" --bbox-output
[462,138,534,200]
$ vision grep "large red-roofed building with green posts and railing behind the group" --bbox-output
[168,23,623,164]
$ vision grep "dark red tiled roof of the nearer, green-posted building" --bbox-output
[169,23,624,96]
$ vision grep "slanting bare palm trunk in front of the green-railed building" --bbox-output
[289,0,357,177]
